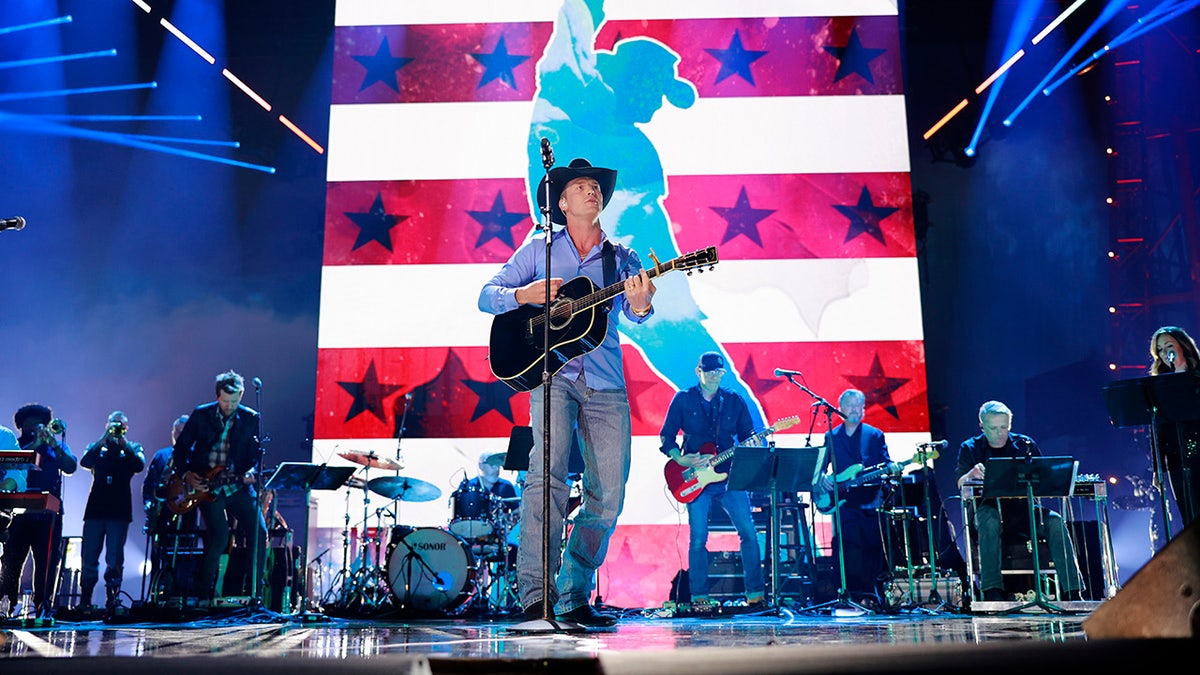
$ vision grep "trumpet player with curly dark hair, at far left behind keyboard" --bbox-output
[0,404,78,619]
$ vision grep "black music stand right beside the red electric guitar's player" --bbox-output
[728,443,824,608]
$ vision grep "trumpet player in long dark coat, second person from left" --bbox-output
[79,411,146,615]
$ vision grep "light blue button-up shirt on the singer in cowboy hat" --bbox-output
[479,228,653,389]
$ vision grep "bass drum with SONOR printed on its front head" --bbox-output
[386,526,475,611]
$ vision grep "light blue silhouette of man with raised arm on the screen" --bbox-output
[528,0,764,428]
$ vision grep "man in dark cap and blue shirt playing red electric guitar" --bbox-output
[659,352,766,608]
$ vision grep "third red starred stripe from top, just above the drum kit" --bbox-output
[314,341,929,438]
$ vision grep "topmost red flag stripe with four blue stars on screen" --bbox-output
[332,17,902,103]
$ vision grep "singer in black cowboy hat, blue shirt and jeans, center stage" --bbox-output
[479,159,654,626]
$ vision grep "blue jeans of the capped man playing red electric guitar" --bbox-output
[688,483,766,598]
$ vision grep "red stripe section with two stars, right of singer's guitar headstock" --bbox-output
[665,173,917,259]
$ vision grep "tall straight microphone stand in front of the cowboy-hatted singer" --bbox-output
[510,138,584,633]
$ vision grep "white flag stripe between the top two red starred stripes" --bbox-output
[328,96,908,181]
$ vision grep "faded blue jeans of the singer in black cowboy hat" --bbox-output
[517,375,632,614]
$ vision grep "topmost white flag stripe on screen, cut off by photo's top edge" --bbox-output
[334,0,898,25]
